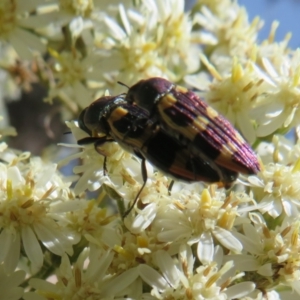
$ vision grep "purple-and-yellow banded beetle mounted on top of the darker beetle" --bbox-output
[125,77,260,180]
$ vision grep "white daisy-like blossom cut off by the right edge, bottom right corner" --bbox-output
[225,213,300,297]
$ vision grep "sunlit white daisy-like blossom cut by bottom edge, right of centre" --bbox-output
[139,245,255,300]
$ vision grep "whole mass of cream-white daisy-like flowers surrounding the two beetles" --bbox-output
[0,0,300,300]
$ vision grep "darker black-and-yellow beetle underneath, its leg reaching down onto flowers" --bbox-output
[78,94,238,217]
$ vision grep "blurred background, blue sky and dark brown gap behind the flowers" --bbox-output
[7,0,300,157]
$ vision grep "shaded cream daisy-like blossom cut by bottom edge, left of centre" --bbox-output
[24,248,142,300]
